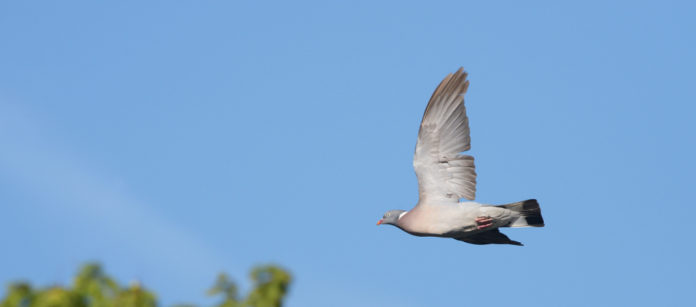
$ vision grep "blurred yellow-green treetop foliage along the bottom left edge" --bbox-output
[0,263,292,307]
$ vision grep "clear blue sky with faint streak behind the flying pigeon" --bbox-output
[0,1,696,307]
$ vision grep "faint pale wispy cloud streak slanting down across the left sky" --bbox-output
[0,102,223,298]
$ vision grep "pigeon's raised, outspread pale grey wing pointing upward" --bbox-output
[413,68,476,203]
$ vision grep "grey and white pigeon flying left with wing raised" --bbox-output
[377,68,544,245]
